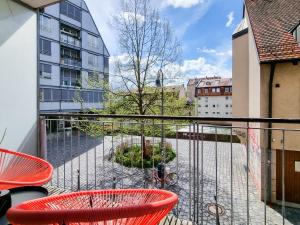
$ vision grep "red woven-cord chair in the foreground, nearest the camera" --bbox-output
[7,189,178,225]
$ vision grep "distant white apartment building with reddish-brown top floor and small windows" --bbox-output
[195,77,232,117]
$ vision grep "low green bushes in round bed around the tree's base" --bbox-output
[114,143,176,168]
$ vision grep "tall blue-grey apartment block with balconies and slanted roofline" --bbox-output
[39,0,109,112]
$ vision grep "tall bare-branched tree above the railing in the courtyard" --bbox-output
[114,0,181,115]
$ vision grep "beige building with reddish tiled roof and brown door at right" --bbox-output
[232,0,300,204]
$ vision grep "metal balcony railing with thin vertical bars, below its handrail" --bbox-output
[41,114,300,224]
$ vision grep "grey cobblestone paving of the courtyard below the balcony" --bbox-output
[48,135,300,225]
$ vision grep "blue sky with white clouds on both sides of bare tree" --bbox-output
[86,0,243,83]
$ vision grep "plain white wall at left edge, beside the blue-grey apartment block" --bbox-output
[0,1,38,155]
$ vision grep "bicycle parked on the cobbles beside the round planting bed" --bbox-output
[146,168,178,187]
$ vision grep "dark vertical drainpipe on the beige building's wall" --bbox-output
[267,63,276,202]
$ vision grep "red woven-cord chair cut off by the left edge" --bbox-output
[0,149,53,190]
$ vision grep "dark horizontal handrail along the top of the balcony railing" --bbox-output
[40,113,300,124]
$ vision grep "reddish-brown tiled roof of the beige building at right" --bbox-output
[245,0,300,62]
